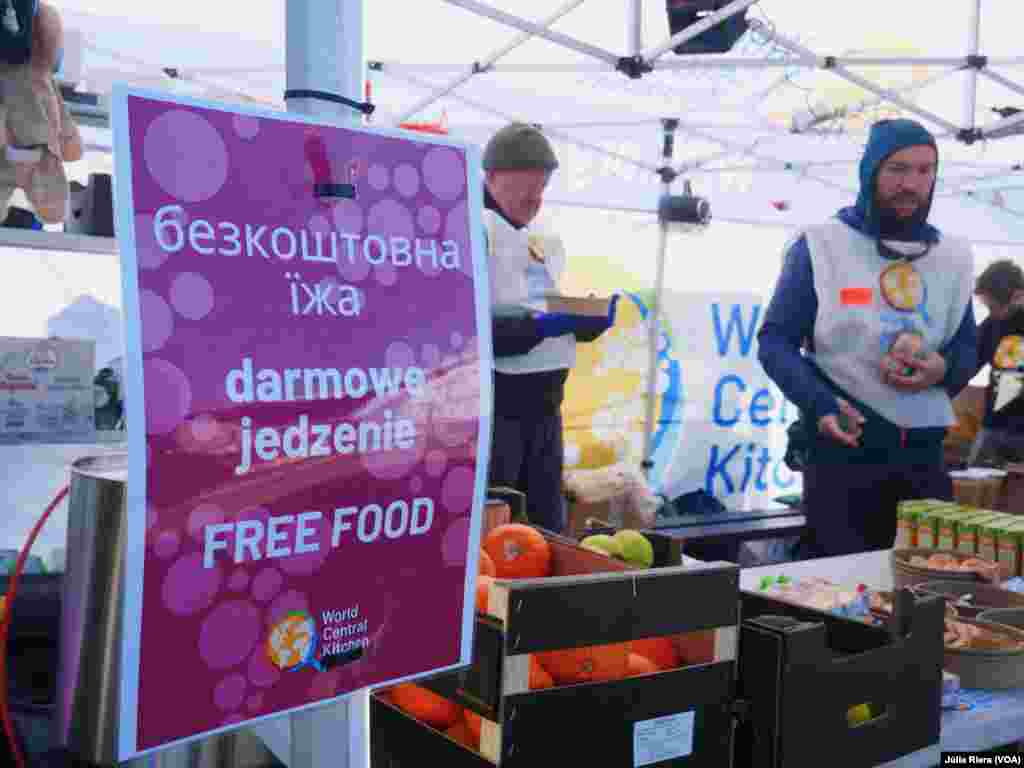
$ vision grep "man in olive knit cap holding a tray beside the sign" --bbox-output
[483,123,615,532]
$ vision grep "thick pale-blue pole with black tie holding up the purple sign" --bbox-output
[285,0,370,768]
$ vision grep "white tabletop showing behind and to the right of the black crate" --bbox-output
[739,550,1024,768]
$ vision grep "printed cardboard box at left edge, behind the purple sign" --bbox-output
[0,337,96,444]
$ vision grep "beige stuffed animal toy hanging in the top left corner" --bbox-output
[0,0,83,224]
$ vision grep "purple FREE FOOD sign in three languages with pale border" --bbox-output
[115,90,490,760]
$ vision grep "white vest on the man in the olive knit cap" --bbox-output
[483,210,575,374]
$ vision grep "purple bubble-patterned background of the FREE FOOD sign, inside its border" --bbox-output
[129,97,480,749]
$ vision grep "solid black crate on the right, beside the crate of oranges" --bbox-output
[735,591,945,768]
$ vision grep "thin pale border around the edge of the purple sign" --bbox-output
[111,83,494,762]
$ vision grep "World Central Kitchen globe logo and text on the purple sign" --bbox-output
[266,605,370,672]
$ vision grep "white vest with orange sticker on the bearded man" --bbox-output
[805,218,974,429]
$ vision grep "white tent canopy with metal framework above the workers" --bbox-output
[54,0,1024,245]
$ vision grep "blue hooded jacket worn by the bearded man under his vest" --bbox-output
[758,120,977,434]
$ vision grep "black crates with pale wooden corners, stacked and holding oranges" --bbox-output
[371,537,739,768]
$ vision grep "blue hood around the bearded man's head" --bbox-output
[839,119,939,243]
